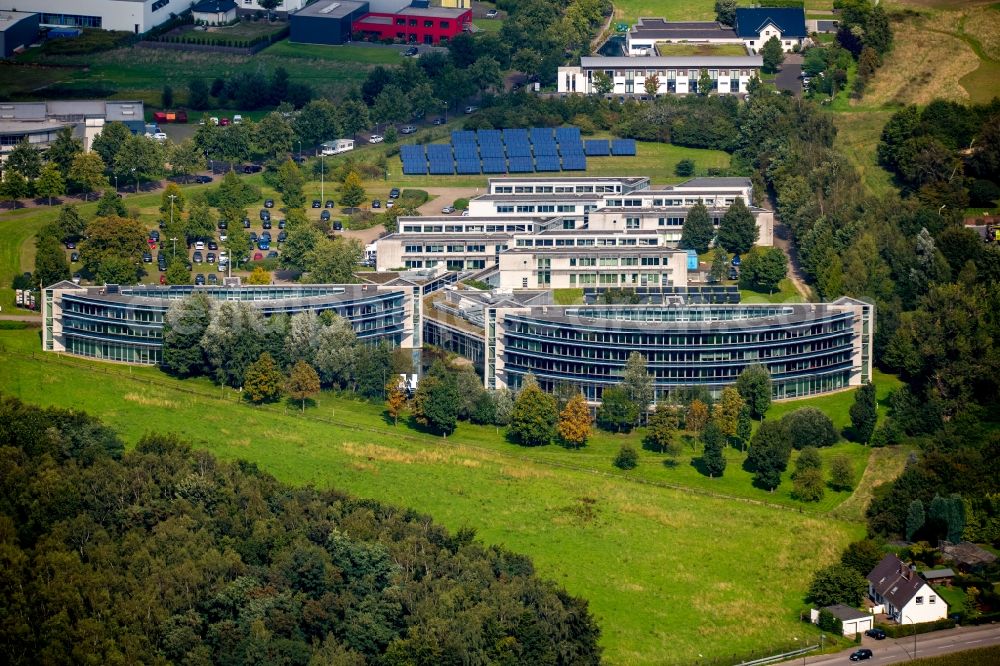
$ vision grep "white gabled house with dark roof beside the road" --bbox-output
[867,555,948,624]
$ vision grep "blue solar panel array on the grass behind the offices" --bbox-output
[400,127,635,175]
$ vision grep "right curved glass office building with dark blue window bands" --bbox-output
[485,298,875,403]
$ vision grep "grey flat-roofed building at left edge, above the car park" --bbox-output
[0,100,145,159]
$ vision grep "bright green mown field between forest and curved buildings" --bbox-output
[0,330,867,664]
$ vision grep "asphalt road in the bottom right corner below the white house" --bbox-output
[784,625,1000,666]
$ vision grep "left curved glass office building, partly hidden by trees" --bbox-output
[42,282,413,365]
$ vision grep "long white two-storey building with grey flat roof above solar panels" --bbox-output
[557,55,764,95]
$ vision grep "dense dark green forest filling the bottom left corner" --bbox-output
[0,398,600,665]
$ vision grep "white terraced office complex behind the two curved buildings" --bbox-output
[376,177,774,272]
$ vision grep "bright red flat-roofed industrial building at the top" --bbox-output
[352,7,472,44]
